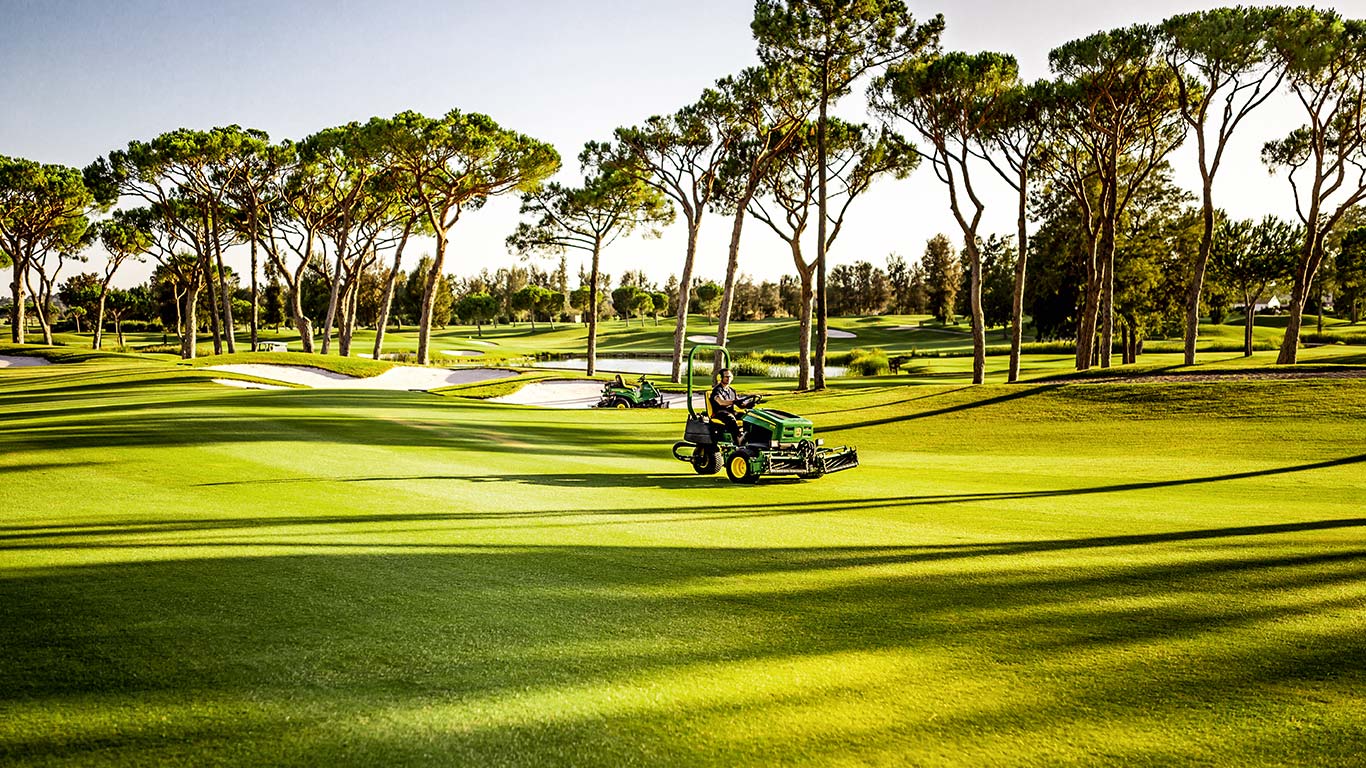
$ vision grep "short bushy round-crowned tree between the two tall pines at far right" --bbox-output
[1212,216,1305,357]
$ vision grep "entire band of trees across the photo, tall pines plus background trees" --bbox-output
[8,0,1366,388]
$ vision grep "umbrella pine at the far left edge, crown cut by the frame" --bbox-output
[0,154,97,344]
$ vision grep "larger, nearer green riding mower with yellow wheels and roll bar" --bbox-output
[673,344,858,484]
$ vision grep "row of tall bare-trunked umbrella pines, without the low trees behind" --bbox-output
[8,0,1366,388]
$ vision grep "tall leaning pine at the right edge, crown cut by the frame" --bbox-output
[1262,8,1366,364]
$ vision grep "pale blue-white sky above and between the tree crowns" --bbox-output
[8,0,1366,286]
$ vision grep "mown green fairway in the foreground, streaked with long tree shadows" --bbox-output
[0,358,1366,767]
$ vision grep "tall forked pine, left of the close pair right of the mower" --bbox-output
[869,53,1019,384]
